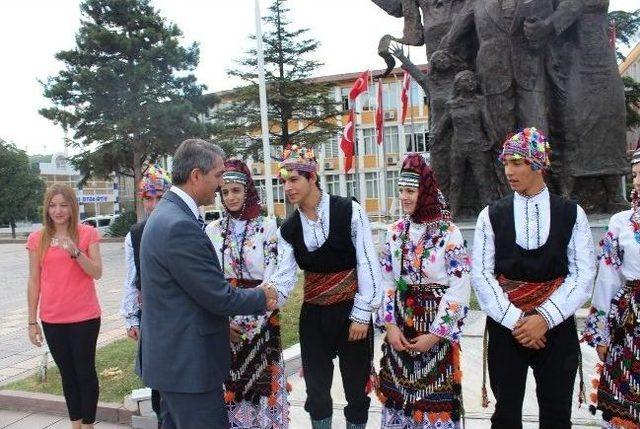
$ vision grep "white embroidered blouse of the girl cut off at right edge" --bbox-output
[583,210,640,347]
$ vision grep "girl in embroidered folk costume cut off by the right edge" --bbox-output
[583,151,640,429]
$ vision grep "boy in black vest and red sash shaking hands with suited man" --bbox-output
[264,145,382,429]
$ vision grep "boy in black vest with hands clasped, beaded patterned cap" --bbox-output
[472,128,595,429]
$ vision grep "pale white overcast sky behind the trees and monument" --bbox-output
[0,0,637,154]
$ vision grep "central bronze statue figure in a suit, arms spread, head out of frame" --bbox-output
[442,0,581,140]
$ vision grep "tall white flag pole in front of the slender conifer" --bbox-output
[255,0,274,216]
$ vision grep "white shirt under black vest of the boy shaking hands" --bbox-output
[270,192,382,323]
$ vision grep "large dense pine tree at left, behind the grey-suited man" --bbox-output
[40,0,214,219]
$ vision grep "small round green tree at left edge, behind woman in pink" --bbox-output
[0,139,44,238]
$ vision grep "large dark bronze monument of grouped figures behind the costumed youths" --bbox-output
[372,0,628,211]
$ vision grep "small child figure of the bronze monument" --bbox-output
[432,70,500,218]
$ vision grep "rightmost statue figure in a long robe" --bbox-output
[550,0,628,211]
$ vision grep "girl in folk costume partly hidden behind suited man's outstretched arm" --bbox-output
[206,159,289,429]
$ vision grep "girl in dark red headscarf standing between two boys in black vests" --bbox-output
[378,154,471,429]
